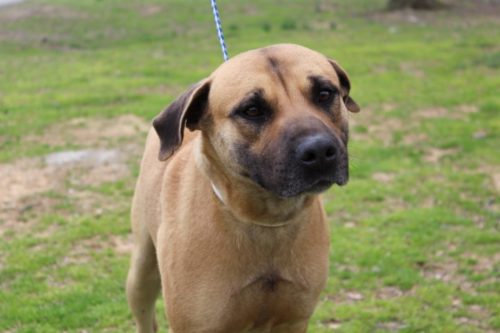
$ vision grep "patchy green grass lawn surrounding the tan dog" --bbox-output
[0,0,500,333]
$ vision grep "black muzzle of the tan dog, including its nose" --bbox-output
[240,131,348,198]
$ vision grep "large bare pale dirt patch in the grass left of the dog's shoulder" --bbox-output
[0,116,149,236]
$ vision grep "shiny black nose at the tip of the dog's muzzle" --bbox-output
[296,134,337,169]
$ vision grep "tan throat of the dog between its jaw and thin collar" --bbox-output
[195,136,313,228]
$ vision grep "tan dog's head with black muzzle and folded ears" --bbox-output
[153,44,359,197]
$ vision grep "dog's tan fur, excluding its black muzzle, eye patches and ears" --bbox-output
[127,45,358,333]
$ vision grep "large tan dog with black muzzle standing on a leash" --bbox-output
[127,45,359,333]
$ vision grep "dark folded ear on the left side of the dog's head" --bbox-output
[153,79,210,161]
